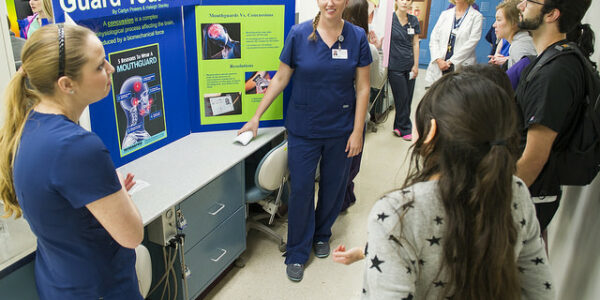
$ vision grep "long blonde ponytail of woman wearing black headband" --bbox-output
[0,69,39,218]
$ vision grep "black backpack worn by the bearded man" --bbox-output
[525,43,600,186]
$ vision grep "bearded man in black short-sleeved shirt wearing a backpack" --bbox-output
[516,0,591,234]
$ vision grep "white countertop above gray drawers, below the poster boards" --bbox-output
[0,127,285,271]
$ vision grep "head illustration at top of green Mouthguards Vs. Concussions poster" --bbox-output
[202,23,242,60]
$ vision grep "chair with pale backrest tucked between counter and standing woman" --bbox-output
[246,140,289,252]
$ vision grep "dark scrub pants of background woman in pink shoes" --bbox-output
[388,70,415,136]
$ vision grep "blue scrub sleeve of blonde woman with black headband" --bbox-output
[50,132,121,208]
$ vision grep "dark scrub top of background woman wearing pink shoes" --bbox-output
[388,12,421,72]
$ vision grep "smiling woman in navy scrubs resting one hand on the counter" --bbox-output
[239,0,372,281]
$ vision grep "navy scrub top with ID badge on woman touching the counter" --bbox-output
[279,21,373,138]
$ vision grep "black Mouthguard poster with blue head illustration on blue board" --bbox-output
[108,44,167,157]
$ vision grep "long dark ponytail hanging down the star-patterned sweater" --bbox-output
[458,141,521,299]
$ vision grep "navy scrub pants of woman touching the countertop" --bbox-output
[285,133,351,264]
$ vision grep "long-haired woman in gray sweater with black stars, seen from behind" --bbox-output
[333,72,555,299]
